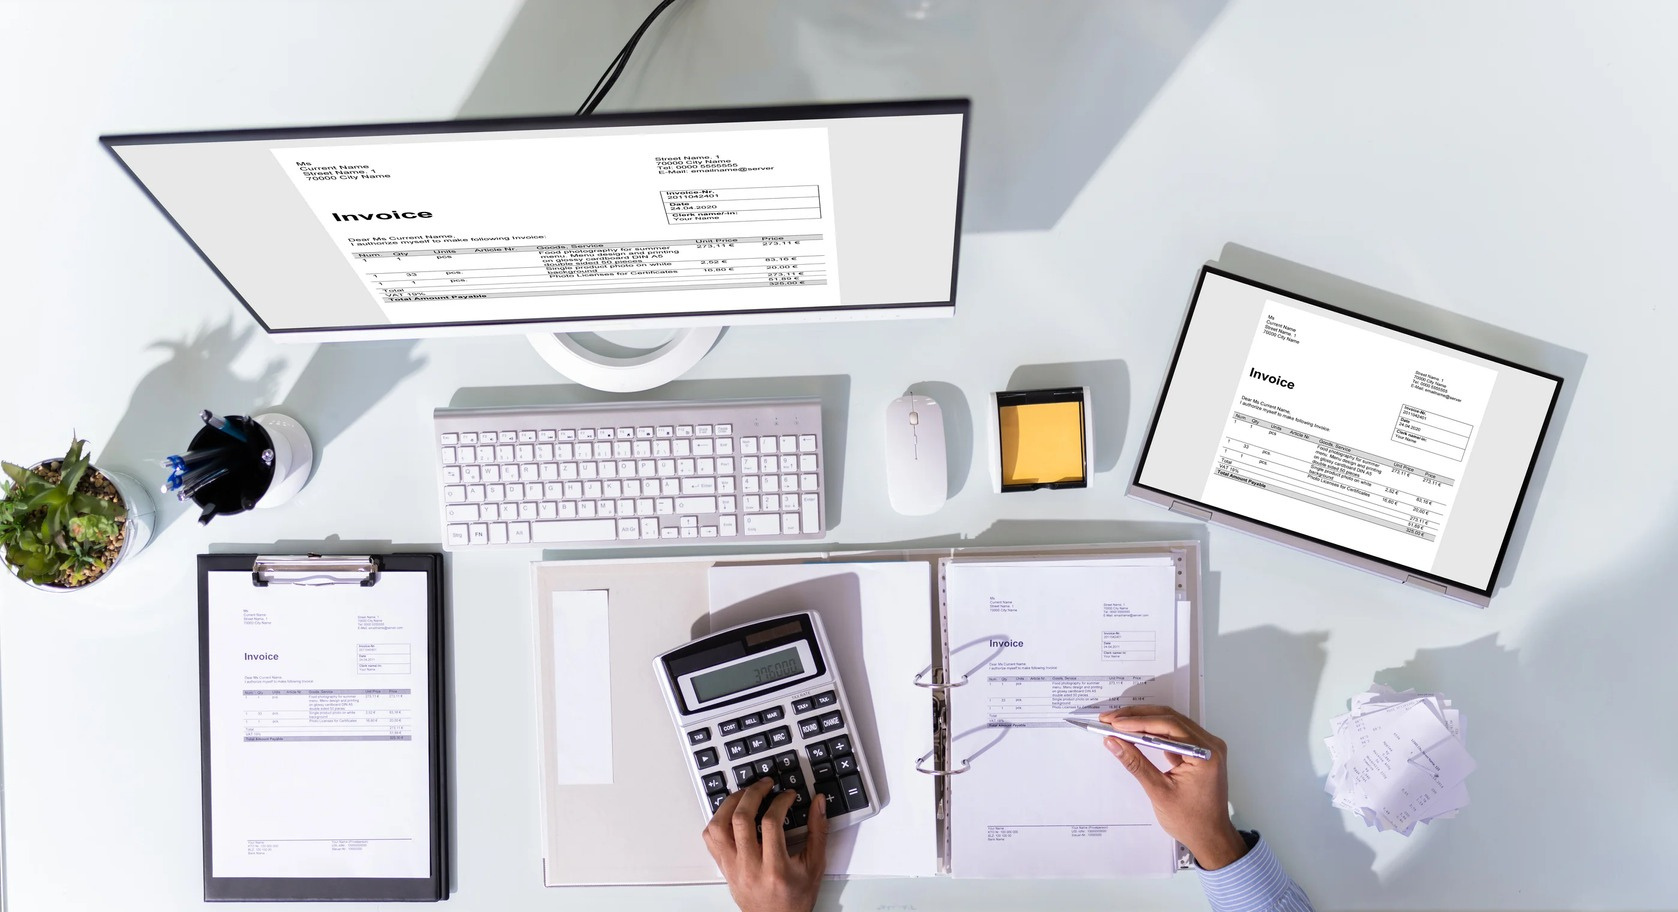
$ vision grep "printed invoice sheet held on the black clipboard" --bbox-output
[208,572,431,878]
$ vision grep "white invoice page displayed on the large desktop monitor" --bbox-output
[274,127,852,324]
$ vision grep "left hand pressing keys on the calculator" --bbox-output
[705,780,827,912]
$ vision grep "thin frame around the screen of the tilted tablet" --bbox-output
[1131,263,1564,599]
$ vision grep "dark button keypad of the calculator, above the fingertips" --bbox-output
[686,691,871,830]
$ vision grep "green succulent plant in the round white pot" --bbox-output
[0,441,128,588]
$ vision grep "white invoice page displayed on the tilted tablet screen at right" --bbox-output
[1201,300,1497,568]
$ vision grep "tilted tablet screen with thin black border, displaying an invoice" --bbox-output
[1136,267,1561,595]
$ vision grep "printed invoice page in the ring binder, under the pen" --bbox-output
[945,560,1191,878]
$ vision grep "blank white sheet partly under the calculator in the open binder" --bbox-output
[710,562,938,877]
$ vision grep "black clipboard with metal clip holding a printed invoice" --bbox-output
[198,553,450,902]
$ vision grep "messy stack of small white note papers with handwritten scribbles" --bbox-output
[1324,684,1475,837]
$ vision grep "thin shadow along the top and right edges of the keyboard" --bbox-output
[448,374,851,526]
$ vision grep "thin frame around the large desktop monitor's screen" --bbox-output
[99,97,972,342]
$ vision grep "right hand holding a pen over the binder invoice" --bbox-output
[1101,706,1247,870]
